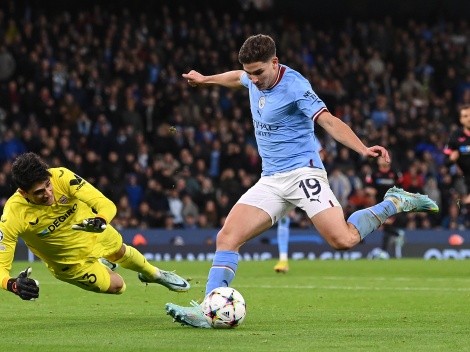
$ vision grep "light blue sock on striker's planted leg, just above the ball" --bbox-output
[206,251,238,296]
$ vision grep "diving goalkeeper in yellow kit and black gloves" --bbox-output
[0,153,190,300]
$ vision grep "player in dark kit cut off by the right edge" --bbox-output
[444,104,470,220]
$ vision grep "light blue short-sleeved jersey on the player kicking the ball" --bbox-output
[240,65,327,176]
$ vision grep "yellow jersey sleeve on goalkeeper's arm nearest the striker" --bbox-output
[53,168,117,223]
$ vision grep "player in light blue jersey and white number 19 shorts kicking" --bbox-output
[165,34,439,328]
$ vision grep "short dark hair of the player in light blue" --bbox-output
[238,34,276,65]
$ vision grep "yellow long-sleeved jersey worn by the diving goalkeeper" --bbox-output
[0,167,116,288]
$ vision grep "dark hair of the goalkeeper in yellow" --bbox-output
[11,153,52,192]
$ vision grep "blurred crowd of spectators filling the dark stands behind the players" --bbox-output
[0,0,470,229]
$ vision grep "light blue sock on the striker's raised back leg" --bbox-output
[348,200,397,239]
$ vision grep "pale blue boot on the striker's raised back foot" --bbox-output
[384,187,439,213]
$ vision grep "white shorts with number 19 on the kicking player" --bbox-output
[237,167,340,224]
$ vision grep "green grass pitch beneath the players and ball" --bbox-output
[0,259,470,352]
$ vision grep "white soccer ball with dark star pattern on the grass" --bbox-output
[202,287,246,329]
